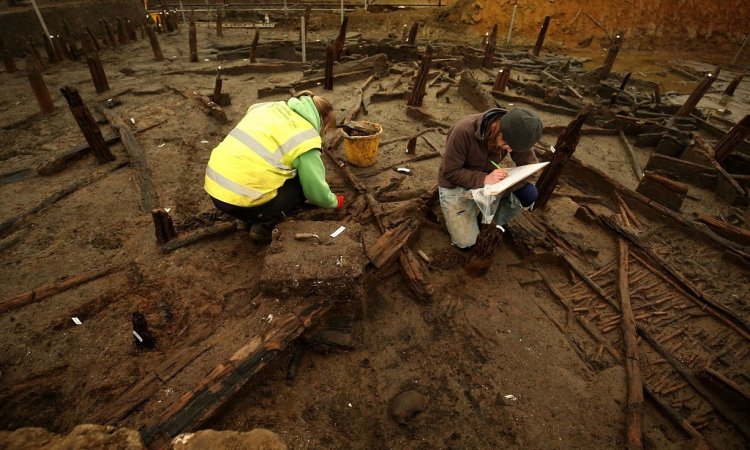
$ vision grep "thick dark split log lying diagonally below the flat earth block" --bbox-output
[142,300,332,445]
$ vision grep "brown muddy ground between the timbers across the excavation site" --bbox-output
[0,5,750,449]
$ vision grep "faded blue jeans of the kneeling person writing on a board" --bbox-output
[438,184,536,248]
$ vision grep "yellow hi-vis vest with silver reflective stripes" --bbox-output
[204,101,322,206]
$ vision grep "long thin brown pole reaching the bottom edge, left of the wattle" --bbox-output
[617,243,643,449]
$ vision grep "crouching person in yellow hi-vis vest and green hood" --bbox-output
[204,91,344,243]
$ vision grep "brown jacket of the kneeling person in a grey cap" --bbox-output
[438,113,539,190]
